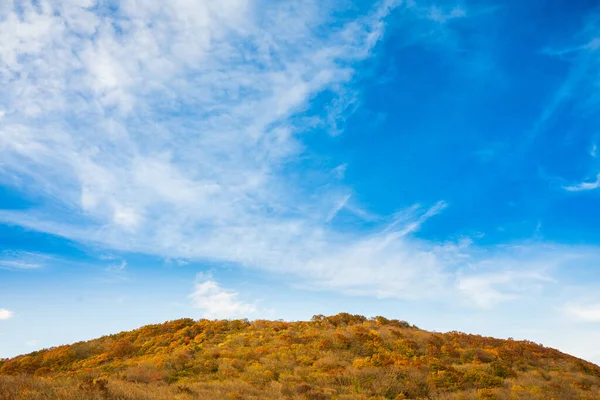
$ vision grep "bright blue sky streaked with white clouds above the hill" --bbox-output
[0,0,600,362]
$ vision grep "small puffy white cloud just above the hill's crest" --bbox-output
[190,274,256,319]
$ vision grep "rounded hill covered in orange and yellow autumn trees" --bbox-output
[0,313,600,400]
